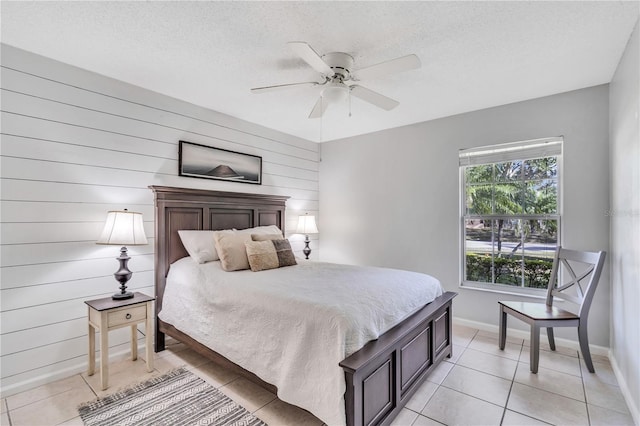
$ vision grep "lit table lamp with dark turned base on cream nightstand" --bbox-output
[96,209,147,299]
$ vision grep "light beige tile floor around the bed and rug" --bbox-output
[0,326,633,426]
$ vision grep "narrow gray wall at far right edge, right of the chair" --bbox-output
[609,18,640,424]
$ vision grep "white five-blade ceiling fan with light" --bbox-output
[251,41,421,118]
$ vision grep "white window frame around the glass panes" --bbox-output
[458,136,564,299]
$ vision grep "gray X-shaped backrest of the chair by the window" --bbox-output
[547,247,607,317]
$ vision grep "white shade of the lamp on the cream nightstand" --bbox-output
[97,210,147,246]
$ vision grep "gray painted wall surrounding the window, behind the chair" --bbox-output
[319,85,609,346]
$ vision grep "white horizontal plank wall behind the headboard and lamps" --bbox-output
[0,45,319,396]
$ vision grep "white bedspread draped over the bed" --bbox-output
[160,257,442,425]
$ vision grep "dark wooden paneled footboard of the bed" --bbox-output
[340,292,457,426]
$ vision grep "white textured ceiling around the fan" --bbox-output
[1,1,639,141]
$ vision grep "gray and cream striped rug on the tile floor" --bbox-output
[78,368,266,426]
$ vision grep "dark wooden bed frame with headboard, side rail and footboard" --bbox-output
[150,186,455,425]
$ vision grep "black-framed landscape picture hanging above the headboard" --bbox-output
[178,141,262,185]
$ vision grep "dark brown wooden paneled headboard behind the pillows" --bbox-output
[149,186,289,317]
